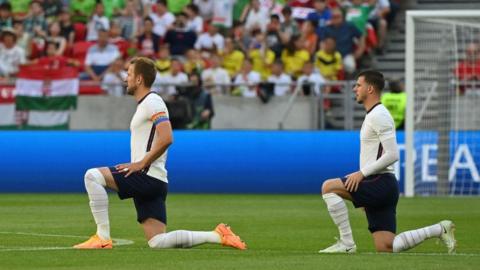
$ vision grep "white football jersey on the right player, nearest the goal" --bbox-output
[360,103,396,174]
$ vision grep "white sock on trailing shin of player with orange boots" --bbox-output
[148,230,221,248]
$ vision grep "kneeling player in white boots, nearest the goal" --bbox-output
[319,71,456,253]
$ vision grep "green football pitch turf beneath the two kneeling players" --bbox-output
[0,194,480,270]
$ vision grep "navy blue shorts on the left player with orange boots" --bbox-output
[109,167,168,224]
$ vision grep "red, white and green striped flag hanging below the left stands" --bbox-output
[15,66,79,129]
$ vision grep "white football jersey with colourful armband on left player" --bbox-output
[130,92,169,183]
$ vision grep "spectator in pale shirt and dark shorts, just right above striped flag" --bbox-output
[81,29,120,82]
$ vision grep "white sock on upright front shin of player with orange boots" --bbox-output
[85,169,110,240]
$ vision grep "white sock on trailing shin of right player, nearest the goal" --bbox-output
[393,224,442,252]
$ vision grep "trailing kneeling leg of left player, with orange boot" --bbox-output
[138,197,246,249]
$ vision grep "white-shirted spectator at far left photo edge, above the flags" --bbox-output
[0,28,26,78]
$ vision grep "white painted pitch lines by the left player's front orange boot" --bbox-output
[0,232,134,252]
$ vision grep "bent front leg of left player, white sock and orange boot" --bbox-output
[74,168,118,248]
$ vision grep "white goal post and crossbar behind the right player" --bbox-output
[404,10,480,197]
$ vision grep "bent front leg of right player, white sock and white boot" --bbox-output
[320,178,356,253]
